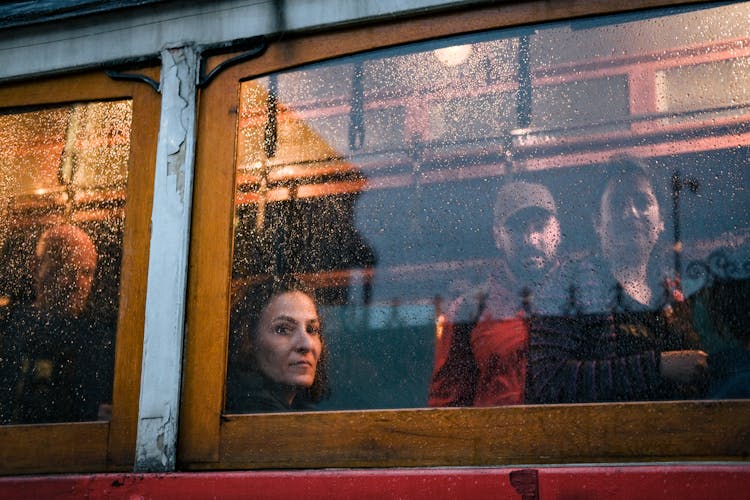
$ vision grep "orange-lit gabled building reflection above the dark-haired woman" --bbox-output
[234,82,376,302]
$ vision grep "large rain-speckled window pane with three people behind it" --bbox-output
[226,4,750,413]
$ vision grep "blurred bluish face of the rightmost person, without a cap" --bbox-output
[598,174,664,266]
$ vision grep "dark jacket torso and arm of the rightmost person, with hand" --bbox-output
[526,311,706,403]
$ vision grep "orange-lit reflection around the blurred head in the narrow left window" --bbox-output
[0,101,132,326]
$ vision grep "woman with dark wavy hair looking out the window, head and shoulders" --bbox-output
[226,279,327,413]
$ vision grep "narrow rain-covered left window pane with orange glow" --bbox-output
[0,101,132,424]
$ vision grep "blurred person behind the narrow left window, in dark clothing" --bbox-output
[0,224,112,423]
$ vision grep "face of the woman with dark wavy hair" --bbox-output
[253,291,322,387]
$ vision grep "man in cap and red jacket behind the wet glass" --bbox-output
[429,182,565,406]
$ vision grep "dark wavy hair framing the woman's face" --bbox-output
[228,276,329,403]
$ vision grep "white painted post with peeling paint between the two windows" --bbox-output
[135,46,199,472]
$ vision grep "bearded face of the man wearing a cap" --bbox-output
[495,207,560,281]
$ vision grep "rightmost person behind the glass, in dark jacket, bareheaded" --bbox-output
[526,158,707,403]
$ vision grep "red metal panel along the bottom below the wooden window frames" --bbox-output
[0,463,750,500]
